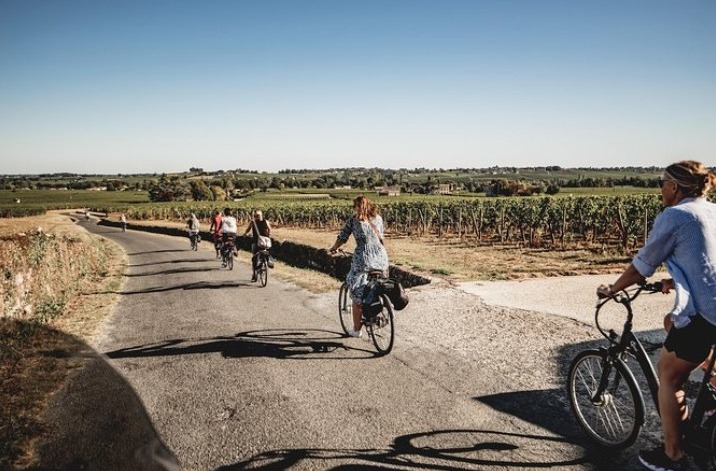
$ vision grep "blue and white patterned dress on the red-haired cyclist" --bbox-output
[338,216,388,304]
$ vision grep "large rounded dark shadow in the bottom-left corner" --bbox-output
[0,320,181,471]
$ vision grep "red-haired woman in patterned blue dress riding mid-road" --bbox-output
[330,195,388,337]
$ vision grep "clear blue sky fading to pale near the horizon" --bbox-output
[0,0,716,174]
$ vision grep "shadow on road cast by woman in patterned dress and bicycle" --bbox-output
[105,329,376,360]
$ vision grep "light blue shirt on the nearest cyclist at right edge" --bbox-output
[632,198,716,328]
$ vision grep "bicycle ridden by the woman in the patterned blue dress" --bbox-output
[338,272,395,355]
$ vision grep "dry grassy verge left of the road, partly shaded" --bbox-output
[0,213,125,469]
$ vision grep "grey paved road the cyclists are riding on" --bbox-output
[43,224,672,470]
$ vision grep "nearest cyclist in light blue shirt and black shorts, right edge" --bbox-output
[597,160,716,470]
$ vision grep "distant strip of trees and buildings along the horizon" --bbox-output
[0,166,672,201]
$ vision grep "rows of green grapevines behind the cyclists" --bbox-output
[106,195,672,253]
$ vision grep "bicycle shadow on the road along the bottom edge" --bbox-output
[216,429,592,471]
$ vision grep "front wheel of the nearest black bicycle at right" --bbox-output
[568,350,644,448]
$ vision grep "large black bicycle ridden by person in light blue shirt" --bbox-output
[567,282,716,469]
